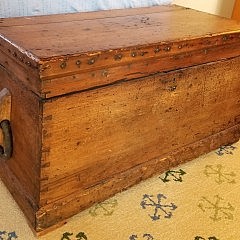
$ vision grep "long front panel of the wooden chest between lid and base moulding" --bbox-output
[36,58,240,231]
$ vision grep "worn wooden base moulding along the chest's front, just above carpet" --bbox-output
[36,124,240,231]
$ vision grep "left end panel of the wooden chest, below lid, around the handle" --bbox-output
[0,65,41,229]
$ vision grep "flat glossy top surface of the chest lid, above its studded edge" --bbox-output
[0,8,240,59]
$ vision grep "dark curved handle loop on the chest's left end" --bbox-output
[0,120,13,160]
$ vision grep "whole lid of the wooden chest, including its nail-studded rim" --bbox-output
[0,5,240,98]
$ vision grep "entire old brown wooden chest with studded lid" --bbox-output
[0,6,240,233]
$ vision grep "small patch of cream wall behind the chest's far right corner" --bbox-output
[173,0,235,18]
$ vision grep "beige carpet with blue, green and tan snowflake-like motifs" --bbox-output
[0,142,240,240]
